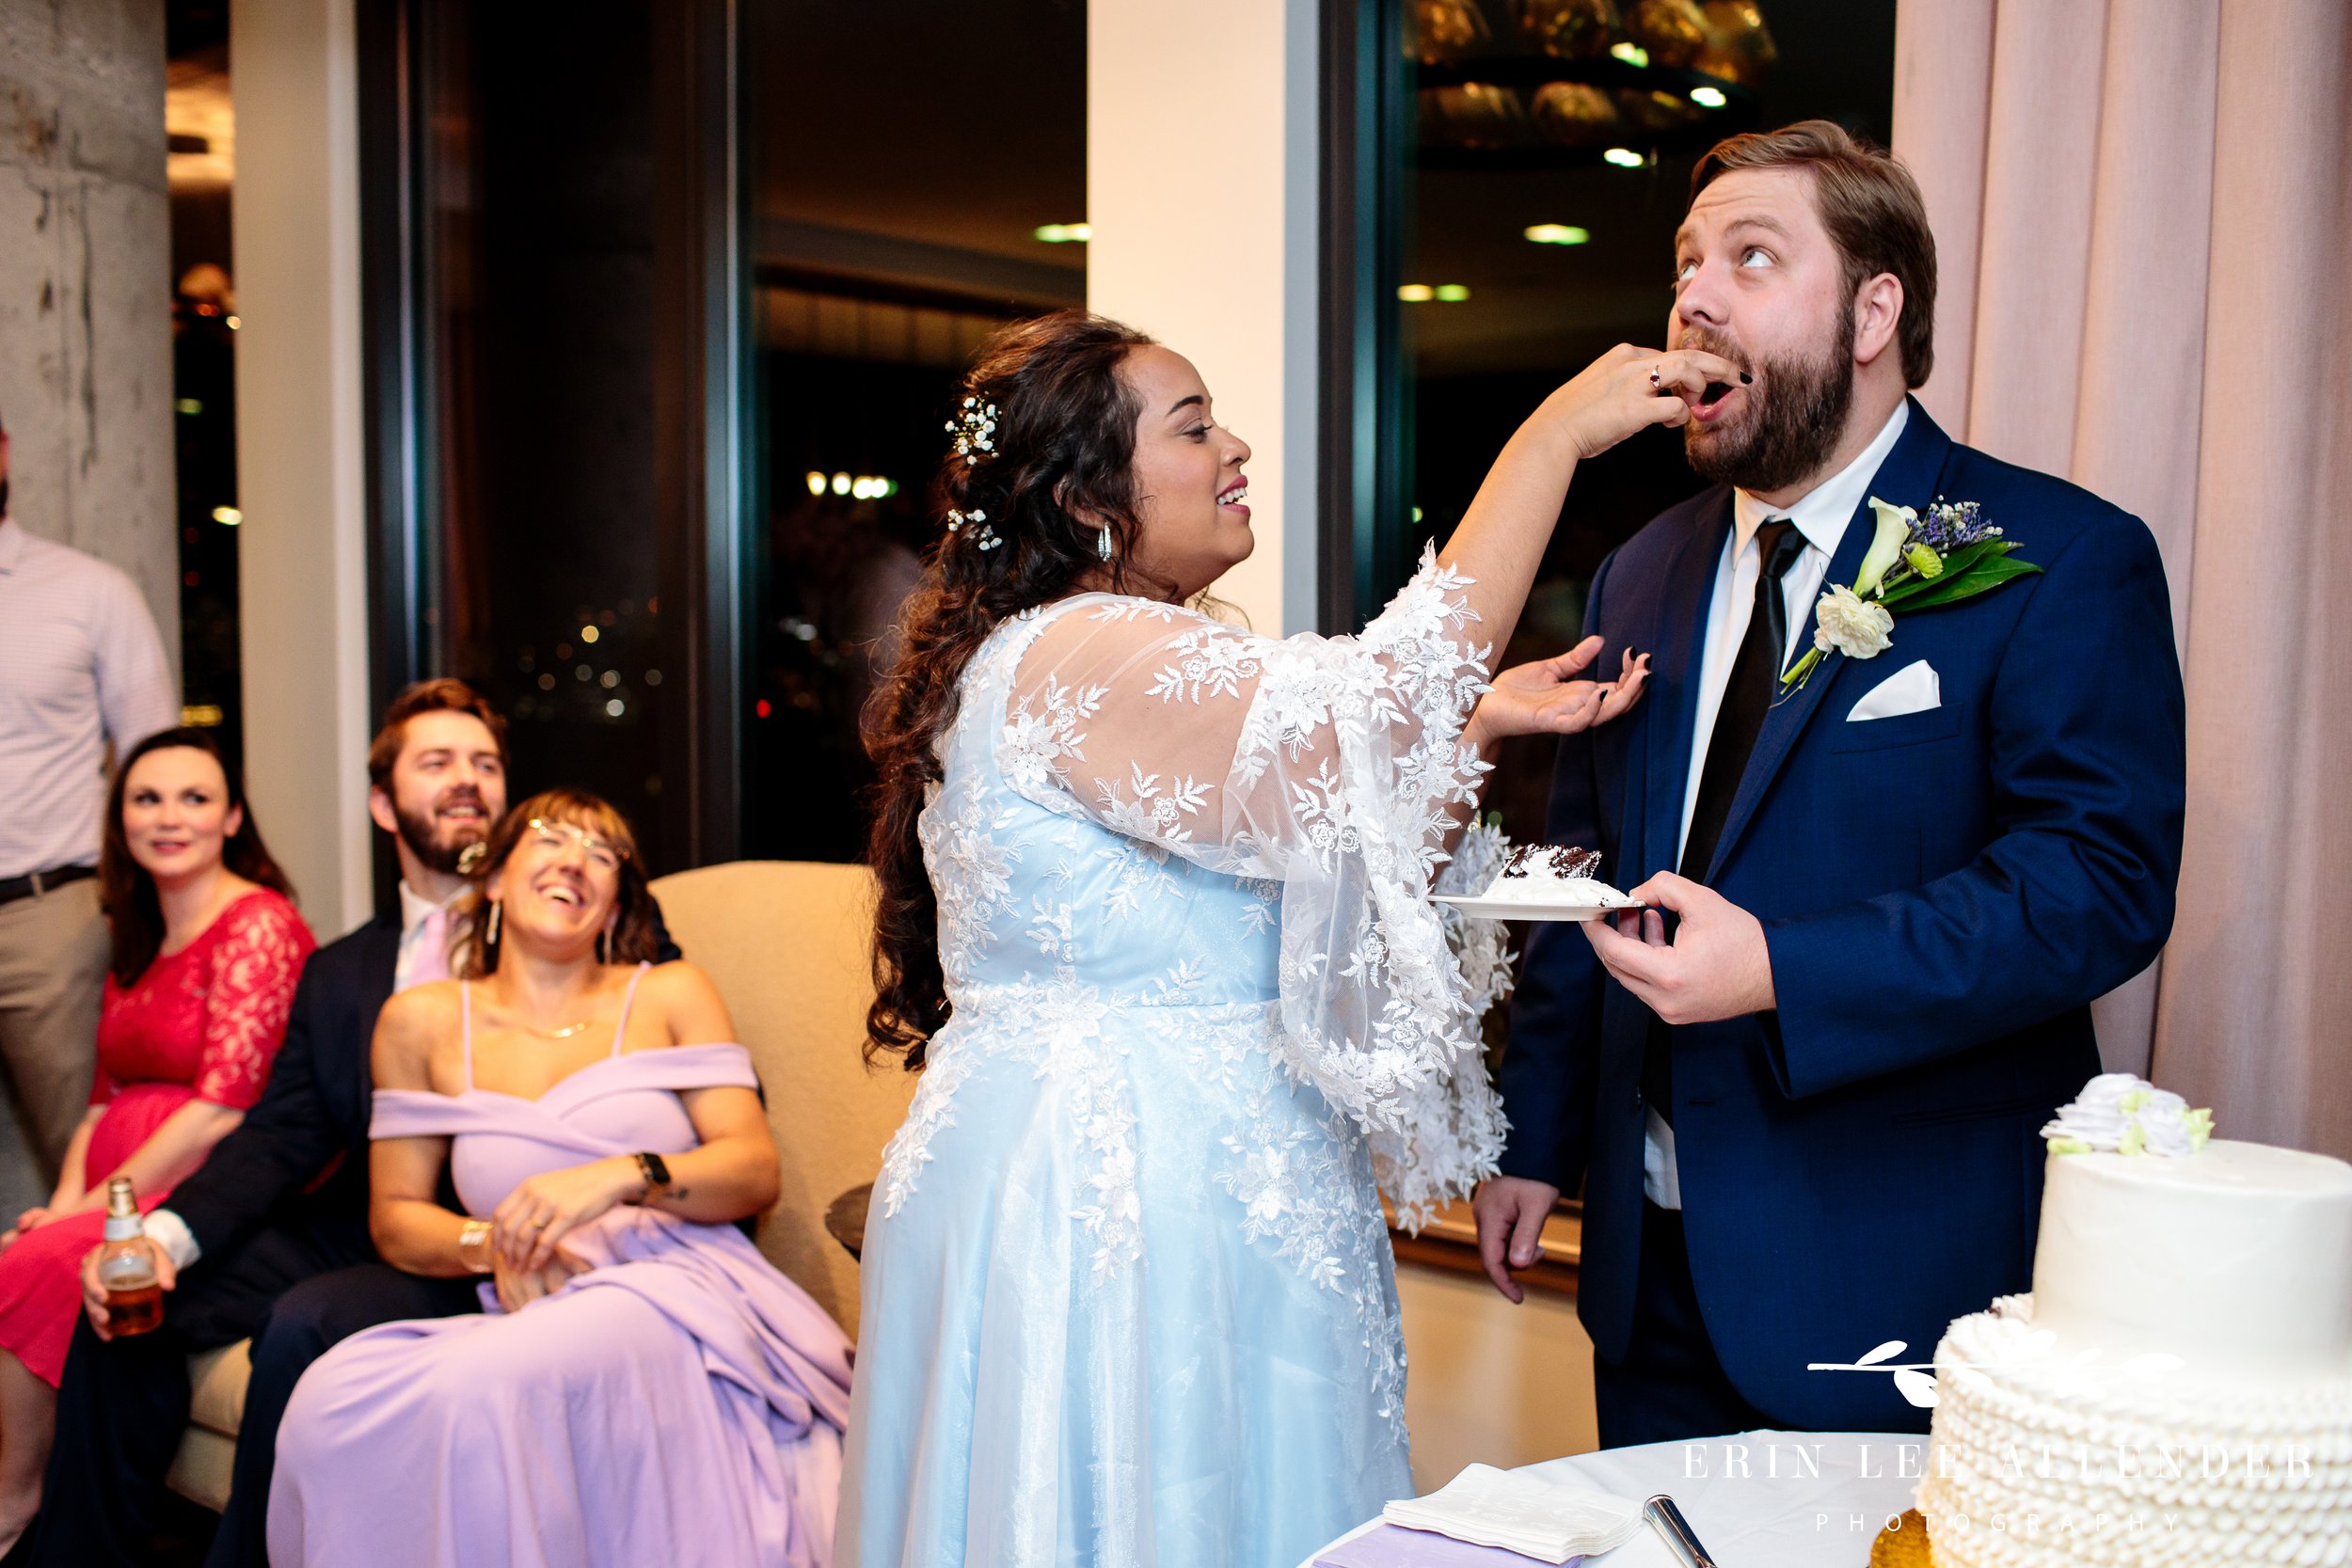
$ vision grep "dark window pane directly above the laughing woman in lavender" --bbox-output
[409,0,701,872]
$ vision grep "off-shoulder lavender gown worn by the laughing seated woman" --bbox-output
[271,969,850,1568]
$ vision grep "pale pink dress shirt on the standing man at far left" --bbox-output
[0,517,179,877]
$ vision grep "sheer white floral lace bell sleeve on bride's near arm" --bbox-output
[997,545,1503,1223]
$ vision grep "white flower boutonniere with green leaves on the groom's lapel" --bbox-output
[1781,496,2042,696]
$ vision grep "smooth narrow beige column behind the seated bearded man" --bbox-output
[229,0,374,938]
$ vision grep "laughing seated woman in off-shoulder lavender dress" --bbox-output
[271,792,850,1568]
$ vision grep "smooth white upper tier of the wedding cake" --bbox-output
[2035,1140,2352,1380]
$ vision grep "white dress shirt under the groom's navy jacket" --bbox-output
[1642,400,1910,1209]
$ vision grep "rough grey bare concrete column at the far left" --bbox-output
[0,0,179,670]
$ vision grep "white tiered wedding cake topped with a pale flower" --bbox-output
[1919,1074,2352,1568]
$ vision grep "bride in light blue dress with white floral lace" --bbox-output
[835,312,1739,1568]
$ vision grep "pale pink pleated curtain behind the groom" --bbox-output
[1894,0,2352,1154]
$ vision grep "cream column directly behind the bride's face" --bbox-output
[1087,0,1320,635]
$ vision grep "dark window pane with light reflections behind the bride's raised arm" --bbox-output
[1374,0,1896,839]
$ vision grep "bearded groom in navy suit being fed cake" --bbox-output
[1477,119,2185,1446]
